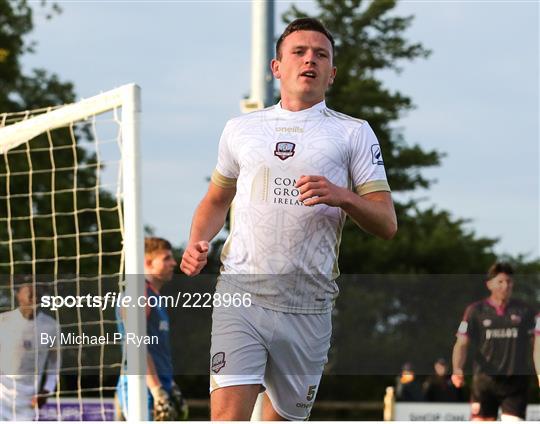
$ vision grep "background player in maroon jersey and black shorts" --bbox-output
[452,262,540,421]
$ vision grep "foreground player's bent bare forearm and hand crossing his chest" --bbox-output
[296,175,397,240]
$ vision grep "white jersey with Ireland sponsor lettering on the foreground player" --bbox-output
[212,101,390,313]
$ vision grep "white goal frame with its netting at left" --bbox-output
[0,84,146,420]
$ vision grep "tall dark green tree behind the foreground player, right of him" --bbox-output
[283,0,540,419]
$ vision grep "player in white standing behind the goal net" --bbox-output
[0,277,60,421]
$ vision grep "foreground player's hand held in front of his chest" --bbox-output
[296,175,349,207]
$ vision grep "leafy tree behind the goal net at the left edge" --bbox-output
[0,0,122,393]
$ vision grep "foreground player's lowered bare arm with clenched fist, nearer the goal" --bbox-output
[180,182,236,276]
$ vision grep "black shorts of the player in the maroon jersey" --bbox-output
[471,374,529,419]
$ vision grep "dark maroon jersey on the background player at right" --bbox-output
[458,299,540,375]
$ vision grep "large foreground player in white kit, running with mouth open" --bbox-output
[180,18,397,420]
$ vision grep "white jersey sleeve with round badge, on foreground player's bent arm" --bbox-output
[351,122,390,196]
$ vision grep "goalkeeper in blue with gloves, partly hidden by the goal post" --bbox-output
[116,237,188,421]
